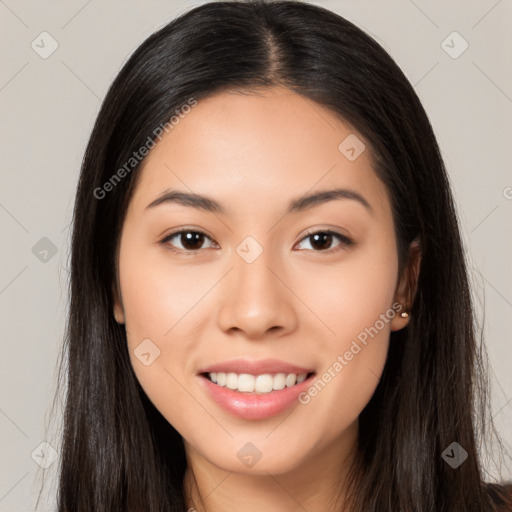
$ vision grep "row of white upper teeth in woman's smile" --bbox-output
[208,372,307,393]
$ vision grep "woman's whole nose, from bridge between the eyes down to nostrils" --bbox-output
[219,237,296,337]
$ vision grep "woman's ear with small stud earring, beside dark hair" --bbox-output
[391,240,421,331]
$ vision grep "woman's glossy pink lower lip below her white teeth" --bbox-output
[199,374,315,420]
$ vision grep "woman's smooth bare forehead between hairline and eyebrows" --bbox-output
[127,87,387,216]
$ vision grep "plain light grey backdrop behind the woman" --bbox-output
[0,0,512,512]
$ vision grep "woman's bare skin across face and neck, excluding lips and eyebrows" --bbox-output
[114,87,418,512]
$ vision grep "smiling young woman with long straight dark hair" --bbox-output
[54,1,512,512]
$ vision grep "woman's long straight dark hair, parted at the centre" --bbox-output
[54,0,510,512]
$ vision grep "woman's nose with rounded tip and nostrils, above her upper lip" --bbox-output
[218,244,298,340]
